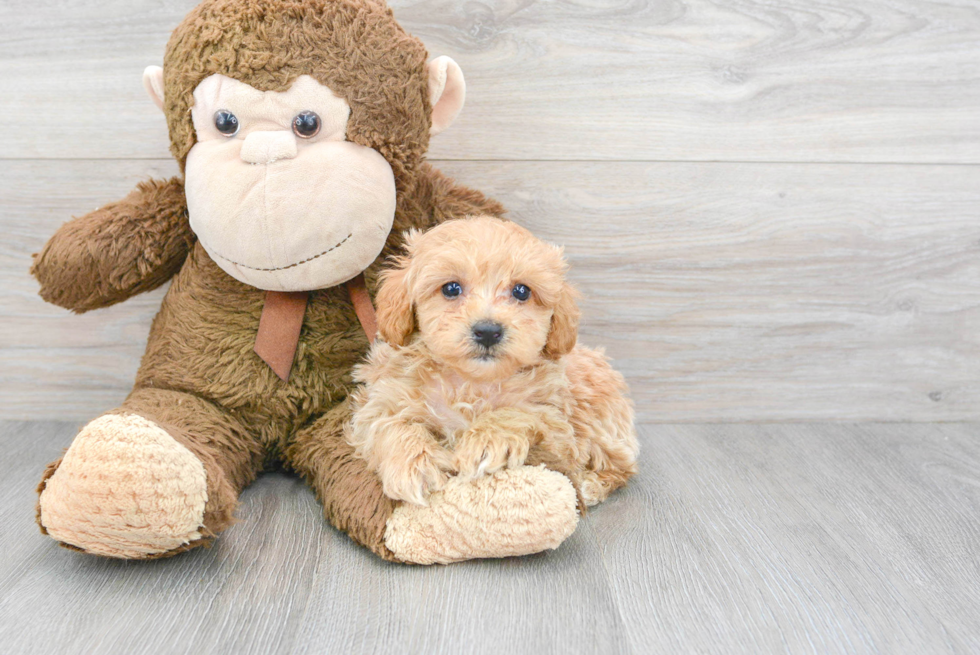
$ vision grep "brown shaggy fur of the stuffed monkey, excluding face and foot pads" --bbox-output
[32,0,503,558]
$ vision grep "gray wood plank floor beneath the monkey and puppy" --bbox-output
[0,422,980,655]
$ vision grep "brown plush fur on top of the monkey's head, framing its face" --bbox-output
[163,0,432,182]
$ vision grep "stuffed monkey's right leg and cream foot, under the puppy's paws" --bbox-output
[286,400,578,564]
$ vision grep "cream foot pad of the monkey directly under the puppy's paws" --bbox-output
[385,466,578,564]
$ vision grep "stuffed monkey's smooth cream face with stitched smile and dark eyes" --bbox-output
[184,75,395,291]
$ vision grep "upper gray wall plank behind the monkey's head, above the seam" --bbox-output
[0,0,980,163]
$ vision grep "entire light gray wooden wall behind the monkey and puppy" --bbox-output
[0,0,980,422]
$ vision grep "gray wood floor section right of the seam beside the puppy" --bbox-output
[589,425,980,653]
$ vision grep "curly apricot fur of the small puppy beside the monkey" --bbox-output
[347,216,638,505]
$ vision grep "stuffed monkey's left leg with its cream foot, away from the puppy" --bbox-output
[37,388,262,559]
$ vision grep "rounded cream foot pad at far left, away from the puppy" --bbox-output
[40,414,208,559]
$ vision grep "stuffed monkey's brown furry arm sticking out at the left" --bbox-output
[31,177,195,313]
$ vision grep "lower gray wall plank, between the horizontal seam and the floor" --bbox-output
[0,161,980,422]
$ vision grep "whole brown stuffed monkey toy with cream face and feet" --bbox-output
[31,0,578,563]
